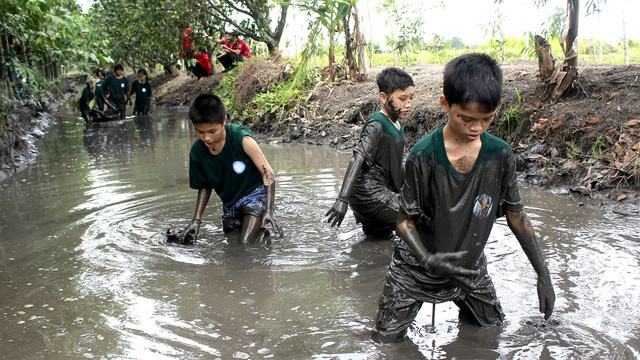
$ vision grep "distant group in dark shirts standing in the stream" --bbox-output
[79,64,152,122]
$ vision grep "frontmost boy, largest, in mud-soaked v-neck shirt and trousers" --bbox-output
[372,54,555,342]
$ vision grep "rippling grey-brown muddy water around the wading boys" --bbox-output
[0,102,640,359]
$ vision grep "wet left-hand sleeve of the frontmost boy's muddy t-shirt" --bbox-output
[400,155,430,223]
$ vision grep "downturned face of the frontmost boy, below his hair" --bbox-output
[440,96,498,142]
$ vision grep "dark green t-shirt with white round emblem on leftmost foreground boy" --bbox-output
[189,124,263,206]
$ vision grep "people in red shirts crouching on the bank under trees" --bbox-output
[179,27,251,80]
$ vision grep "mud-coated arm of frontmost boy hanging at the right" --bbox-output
[506,210,556,319]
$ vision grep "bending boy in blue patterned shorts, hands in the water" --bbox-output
[174,94,283,244]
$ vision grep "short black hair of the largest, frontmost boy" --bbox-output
[443,53,502,111]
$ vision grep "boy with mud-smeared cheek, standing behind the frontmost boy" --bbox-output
[326,68,415,239]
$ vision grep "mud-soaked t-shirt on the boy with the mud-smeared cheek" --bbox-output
[353,112,404,197]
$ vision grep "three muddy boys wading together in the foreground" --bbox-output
[174,53,555,342]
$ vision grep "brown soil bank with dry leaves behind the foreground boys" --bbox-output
[156,63,640,211]
